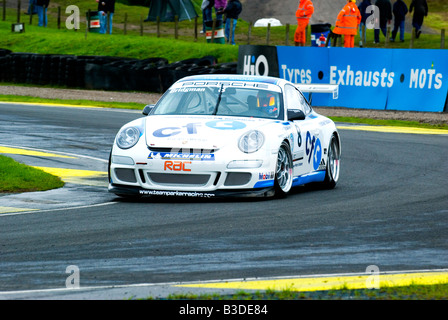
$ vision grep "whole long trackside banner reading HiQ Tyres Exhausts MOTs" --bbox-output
[245,46,448,112]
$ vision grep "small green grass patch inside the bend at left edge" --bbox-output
[0,155,64,193]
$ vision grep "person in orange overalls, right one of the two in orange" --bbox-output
[333,0,361,48]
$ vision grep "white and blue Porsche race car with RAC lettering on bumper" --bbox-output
[109,75,341,198]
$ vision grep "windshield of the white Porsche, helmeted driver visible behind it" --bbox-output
[152,85,283,119]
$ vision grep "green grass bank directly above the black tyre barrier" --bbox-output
[0,21,238,63]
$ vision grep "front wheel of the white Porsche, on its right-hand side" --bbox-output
[274,141,293,197]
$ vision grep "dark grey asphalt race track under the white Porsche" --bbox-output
[0,104,448,298]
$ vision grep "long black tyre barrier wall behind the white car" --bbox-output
[0,49,237,93]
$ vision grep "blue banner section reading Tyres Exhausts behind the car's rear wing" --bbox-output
[277,46,393,109]
